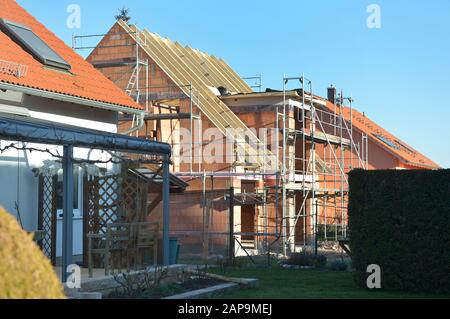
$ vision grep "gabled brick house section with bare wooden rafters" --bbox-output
[87,21,270,255]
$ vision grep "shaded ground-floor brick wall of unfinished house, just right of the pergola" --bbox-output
[149,177,241,257]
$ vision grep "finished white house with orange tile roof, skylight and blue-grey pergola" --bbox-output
[0,0,171,279]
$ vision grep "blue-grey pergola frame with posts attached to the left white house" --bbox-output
[0,114,171,282]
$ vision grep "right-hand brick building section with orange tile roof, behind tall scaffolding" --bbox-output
[221,87,440,249]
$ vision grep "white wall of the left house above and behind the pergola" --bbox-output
[0,91,117,256]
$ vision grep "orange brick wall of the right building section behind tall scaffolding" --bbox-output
[225,97,408,243]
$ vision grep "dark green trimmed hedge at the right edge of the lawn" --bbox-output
[349,170,450,293]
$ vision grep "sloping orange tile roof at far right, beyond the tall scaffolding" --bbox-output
[327,101,441,169]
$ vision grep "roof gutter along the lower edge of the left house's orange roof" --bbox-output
[0,82,145,117]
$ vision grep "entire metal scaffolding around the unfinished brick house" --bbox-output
[72,26,369,262]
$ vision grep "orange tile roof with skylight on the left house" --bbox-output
[0,0,142,109]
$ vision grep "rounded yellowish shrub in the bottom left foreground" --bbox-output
[0,209,65,299]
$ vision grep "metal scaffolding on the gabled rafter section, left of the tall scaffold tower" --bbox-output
[72,25,279,260]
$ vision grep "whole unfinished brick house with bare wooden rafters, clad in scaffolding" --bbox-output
[73,21,439,257]
